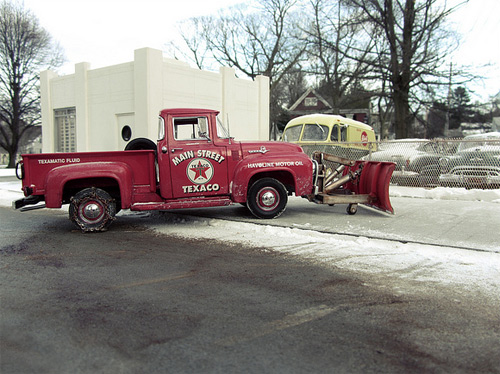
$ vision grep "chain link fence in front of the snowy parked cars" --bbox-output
[302,133,500,189]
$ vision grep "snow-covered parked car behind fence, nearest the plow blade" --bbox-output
[364,139,455,186]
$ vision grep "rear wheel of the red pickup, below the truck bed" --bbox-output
[69,187,116,232]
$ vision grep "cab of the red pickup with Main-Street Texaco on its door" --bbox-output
[157,109,236,199]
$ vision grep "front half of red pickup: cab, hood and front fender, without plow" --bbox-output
[146,108,313,213]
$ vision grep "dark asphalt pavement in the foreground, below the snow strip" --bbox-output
[0,208,500,374]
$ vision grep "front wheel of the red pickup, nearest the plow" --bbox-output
[247,178,288,219]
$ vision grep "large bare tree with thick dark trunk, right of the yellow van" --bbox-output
[347,0,464,138]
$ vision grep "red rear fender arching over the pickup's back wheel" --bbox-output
[45,162,132,209]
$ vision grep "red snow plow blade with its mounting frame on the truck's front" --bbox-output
[308,152,396,214]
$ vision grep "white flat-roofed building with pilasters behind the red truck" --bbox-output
[40,48,269,153]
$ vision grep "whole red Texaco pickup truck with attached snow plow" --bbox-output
[13,109,394,232]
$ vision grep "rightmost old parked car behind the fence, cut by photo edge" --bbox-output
[439,132,500,188]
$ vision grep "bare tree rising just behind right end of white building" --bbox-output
[174,0,306,134]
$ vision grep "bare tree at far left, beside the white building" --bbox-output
[0,1,63,168]
